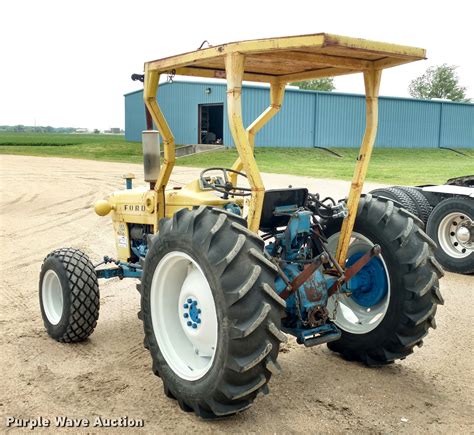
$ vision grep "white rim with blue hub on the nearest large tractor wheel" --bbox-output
[150,251,218,381]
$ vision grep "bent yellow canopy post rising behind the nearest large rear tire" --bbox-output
[225,53,265,232]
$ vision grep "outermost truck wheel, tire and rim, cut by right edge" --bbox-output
[427,198,474,273]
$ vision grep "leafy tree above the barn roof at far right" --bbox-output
[408,63,470,102]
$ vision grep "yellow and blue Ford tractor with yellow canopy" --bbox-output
[39,33,443,419]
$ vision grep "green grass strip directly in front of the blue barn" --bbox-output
[178,148,474,185]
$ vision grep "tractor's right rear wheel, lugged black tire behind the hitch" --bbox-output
[325,194,443,365]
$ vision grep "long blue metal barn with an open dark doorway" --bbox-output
[125,81,474,148]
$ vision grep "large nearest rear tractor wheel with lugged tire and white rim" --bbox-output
[141,206,286,419]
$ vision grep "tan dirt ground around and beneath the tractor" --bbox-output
[0,156,474,433]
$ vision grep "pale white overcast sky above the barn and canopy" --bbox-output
[0,0,474,130]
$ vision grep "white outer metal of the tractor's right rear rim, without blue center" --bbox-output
[327,232,390,334]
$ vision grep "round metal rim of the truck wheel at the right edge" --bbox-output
[438,212,474,258]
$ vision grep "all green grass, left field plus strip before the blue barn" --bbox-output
[0,132,474,185]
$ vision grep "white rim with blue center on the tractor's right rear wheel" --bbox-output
[327,232,390,334]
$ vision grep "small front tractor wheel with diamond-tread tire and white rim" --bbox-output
[39,248,100,343]
